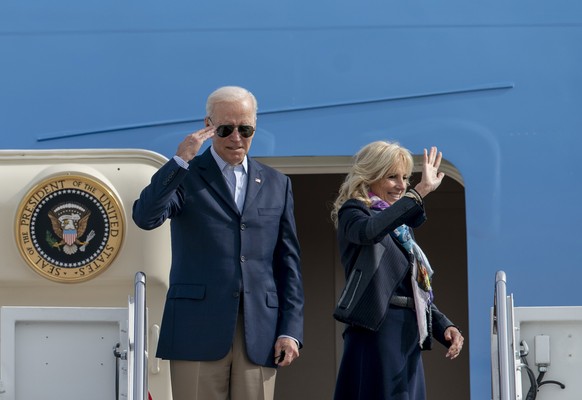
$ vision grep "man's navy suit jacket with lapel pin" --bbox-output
[133,149,304,367]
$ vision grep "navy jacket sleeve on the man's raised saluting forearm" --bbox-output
[132,159,188,230]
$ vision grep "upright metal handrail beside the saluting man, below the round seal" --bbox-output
[133,272,148,400]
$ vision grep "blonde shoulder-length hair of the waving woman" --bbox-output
[331,141,414,228]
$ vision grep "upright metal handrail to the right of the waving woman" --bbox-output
[493,271,513,400]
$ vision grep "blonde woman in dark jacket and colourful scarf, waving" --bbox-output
[332,141,464,400]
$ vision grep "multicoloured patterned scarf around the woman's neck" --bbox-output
[368,192,434,346]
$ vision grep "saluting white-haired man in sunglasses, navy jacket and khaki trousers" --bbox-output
[133,86,303,400]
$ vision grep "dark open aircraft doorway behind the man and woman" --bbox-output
[260,157,470,400]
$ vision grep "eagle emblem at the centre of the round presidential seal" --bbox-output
[46,203,95,255]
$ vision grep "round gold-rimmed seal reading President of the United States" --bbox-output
[16,175,125,283]
